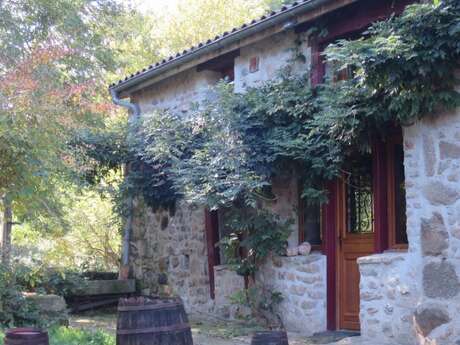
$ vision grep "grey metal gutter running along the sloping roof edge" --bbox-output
[110,0,332,96]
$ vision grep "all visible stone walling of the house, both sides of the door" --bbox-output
[126,19,460,345]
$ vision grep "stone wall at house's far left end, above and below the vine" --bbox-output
[130,63,224,312]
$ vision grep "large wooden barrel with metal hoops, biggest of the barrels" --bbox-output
[117,297,193,345]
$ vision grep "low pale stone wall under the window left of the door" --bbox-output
[257,253,327,335]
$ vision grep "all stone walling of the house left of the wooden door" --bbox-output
[126,30,326,334]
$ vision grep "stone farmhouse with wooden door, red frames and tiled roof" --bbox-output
[110,0,460,345]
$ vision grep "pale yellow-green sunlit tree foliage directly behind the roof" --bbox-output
[109,0,292,81]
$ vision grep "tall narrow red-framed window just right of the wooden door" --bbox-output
[387,134,408,249]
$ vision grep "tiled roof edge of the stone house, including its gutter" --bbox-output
[110,0,352,93]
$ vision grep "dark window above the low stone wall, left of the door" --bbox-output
[299,195,323,250]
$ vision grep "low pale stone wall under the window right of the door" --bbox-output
[358,253,420,345]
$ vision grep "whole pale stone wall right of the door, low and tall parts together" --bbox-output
[359,101,460,345]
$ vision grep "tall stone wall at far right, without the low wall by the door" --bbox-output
[404,109,460,345]
